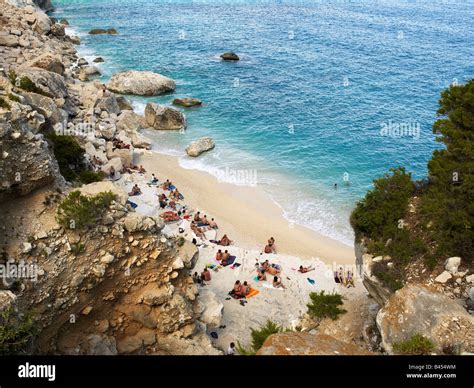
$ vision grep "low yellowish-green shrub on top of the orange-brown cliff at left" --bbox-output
[56,191,116,229]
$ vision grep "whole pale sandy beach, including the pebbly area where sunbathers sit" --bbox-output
[116,150,366,350]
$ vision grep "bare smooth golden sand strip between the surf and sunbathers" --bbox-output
[136,151,355,265]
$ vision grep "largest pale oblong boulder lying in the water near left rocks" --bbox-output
[107,70,176,96]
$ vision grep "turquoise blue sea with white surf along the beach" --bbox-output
[54,0,474,245]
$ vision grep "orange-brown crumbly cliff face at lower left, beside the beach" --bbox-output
[4,182,219,354]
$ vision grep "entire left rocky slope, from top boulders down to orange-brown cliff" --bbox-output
[0,0,218,354]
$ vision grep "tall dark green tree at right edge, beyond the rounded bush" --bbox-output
[421,79,474,261]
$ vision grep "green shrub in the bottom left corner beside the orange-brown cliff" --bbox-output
[0,307,36,355]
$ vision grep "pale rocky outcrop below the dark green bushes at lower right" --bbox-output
[355,236,474,354]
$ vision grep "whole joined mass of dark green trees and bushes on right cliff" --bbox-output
[351,80,474,290]
